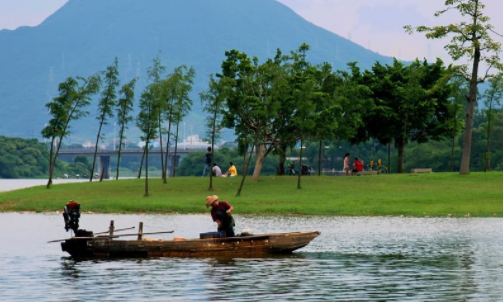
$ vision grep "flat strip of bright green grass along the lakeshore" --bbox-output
[0,172,503,217]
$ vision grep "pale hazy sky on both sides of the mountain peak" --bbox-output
[0,0,503,62]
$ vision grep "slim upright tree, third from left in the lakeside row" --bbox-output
[115,79,136,180]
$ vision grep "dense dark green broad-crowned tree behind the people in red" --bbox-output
[354,59,454,172]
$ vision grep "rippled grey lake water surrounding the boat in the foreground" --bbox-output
[0,214,503,301]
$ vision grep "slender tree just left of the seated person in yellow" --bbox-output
[199,75,228,191]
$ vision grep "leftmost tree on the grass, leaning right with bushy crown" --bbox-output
[42,75,101,189]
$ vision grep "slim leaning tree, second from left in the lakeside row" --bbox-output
[89,58,120,181]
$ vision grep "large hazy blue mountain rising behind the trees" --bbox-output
[0,0,391,142]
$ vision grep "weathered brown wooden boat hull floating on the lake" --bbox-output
[61,231,320,258]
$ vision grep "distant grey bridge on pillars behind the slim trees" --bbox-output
[58,148,204,179]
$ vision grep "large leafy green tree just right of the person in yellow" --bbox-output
[218,46,294,181]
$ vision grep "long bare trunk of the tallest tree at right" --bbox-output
[459,41,480,175]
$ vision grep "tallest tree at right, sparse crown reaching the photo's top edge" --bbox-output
[405,0,503,174]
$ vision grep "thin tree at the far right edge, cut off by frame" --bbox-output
[483,73,503,172]
